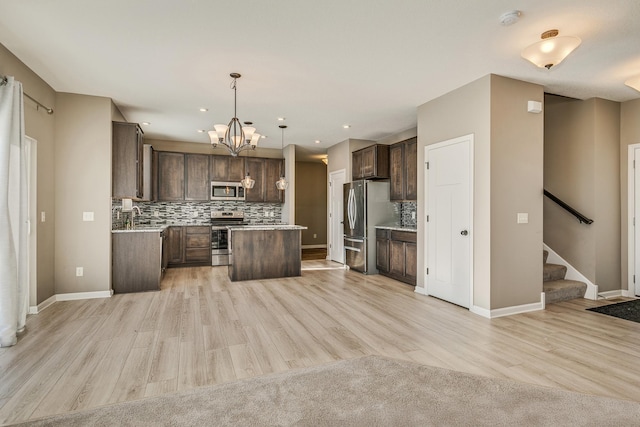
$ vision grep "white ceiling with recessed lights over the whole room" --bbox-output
[0,0,640,160]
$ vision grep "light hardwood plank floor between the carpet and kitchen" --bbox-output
[0,261,640,423]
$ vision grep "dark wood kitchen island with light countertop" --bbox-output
[227,225,307,282]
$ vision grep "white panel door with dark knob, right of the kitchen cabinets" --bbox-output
[425,135,473,308]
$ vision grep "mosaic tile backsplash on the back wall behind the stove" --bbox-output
[111,199,282,230]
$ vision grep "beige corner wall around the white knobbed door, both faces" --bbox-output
[418,75,544,310]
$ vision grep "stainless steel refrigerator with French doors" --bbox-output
[343,180,398,274]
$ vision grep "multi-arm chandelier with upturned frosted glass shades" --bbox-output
[208,73,260,157]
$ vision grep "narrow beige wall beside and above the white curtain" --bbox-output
[0,44,57,306]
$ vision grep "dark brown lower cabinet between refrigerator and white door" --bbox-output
[376,229,418,286]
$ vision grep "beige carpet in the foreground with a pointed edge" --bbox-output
[11,356,640,426]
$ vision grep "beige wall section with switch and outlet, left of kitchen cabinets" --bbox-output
[55,93,112,294]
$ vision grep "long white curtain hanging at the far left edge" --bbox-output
[0,77,29,347]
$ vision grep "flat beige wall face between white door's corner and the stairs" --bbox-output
[491,75,544,309]
